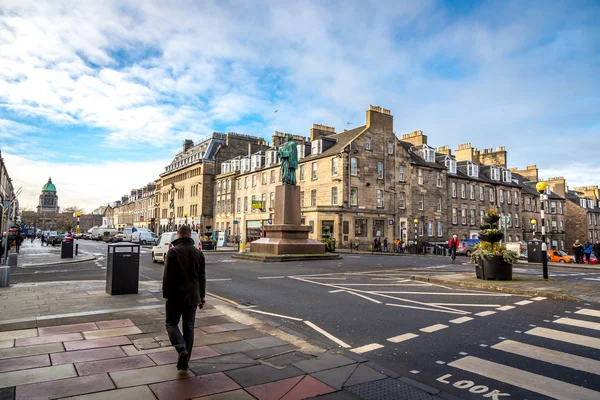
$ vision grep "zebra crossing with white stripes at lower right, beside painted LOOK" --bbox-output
[437,308,600,400]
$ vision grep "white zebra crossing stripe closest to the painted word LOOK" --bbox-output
[448,356,600,400]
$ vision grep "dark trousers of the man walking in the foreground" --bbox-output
[165,300,198,356]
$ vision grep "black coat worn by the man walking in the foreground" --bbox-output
[163,238,206,306]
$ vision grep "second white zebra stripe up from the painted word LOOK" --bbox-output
[492,340,600,375]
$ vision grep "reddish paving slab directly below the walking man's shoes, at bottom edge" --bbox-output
[150,372,240,400]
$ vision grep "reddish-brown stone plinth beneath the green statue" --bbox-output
[250,185,325,255]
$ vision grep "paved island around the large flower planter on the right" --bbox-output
[412,270,600,303]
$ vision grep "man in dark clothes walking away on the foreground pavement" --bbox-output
[162,225,206,370]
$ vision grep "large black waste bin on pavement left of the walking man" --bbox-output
[106,243,140,295]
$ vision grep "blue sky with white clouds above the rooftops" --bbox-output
[0,0,600,211]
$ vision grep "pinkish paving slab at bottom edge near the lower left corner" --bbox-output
[15,374,115,400]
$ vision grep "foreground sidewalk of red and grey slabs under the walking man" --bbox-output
[0,281,452,400]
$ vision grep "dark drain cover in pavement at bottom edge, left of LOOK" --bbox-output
[345,378,435,400]
